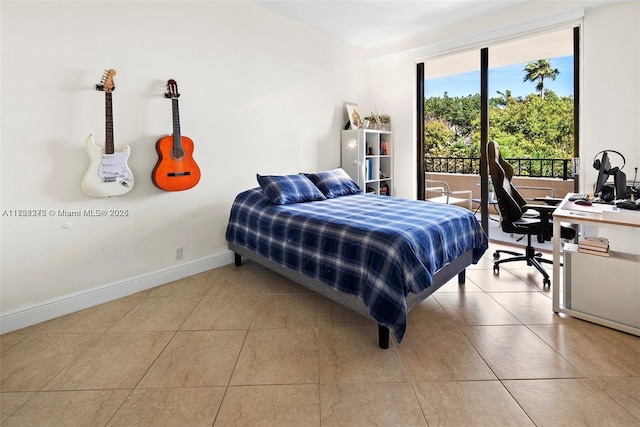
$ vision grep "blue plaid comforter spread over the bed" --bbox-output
[226,188,488,342]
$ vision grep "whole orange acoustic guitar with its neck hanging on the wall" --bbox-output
[151,80,200,191]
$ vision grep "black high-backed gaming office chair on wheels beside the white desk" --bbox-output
[487,141,575,286]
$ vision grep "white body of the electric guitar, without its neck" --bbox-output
[82,135,134,197]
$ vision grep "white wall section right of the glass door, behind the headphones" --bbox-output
[580,1,640,193]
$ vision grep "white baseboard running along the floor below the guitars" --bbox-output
[0,251,233,334]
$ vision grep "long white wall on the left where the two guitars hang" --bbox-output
[1,1,369,331]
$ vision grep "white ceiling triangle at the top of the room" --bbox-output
[254,0,531,48]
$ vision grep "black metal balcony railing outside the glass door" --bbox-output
[424,157,573,181]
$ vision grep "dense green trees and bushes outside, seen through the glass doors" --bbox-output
[425,90,573,173]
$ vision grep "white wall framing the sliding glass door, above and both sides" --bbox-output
[367,1,640,198]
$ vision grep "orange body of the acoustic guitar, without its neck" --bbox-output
[151,135,200,191]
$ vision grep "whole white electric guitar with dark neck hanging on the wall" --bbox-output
[82,70,133,197]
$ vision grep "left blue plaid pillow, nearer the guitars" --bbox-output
[256,174,326,205]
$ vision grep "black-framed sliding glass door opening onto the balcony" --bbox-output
[417,28,579,241]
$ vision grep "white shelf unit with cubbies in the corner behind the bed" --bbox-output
[340,129,393,196]
